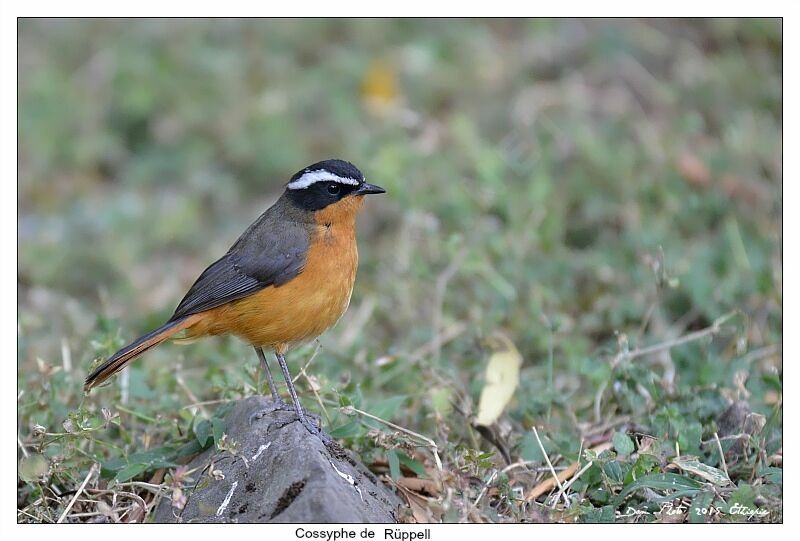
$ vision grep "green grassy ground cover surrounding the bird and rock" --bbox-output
[17,20,783,522]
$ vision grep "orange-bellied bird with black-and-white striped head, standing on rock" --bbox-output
[84,159,386,435]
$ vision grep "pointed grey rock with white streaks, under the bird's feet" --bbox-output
[155,396,401,523]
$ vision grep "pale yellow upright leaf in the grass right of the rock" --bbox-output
[475,335,522,426]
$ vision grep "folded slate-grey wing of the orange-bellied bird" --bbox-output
[170,216,308,321]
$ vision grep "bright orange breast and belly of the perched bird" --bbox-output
[186,224,358,353]
